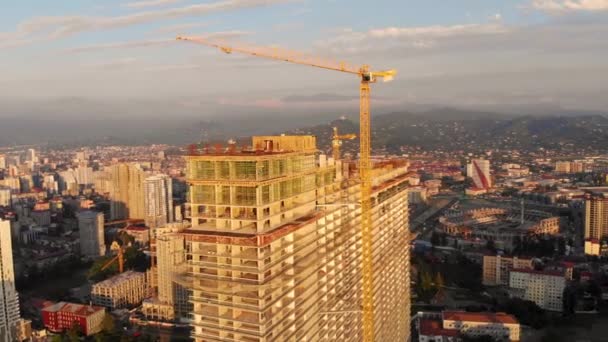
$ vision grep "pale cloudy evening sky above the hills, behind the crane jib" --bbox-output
[0,0,608,117]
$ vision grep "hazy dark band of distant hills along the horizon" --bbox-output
[0,107,608,151]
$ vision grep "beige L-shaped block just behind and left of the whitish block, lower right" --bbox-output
[483,255,533,286]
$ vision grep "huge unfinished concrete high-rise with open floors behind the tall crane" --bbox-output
[173,136,410,342]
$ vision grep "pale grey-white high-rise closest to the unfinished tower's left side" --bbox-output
[144,175,173,228]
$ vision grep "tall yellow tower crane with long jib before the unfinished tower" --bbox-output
[177,37,397,342]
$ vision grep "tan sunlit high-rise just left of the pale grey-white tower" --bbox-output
[110,163,146,220]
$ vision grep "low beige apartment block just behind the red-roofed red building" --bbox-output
[91,271,148,310]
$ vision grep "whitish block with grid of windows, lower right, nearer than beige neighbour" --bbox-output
[509,269,567,311]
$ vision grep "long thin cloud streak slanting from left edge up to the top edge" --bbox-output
[0,0,294,46]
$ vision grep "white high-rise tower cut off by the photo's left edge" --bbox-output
[0,219,20,342]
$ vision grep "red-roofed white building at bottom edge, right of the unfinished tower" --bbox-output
[416,311,521,342]
